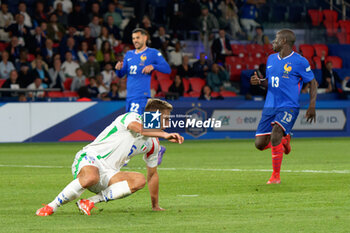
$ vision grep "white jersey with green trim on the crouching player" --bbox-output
[83,112,160,170]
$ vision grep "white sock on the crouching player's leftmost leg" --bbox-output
[48,179,85,211]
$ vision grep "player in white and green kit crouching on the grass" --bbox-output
[36,99,184,216]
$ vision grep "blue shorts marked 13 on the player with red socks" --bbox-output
[255,108,299,136]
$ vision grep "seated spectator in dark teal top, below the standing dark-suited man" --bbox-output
[207,63,230,92]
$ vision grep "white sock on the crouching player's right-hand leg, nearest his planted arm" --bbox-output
[88,180,131,203]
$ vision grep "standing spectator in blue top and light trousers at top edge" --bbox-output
[240,0,266,40]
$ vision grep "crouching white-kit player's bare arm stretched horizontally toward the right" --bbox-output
[128,121,184,144]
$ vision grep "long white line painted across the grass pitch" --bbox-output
[0,164,350,174]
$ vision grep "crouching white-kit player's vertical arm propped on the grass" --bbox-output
[147,167,164,211]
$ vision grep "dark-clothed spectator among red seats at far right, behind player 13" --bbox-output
[320,51,342,93]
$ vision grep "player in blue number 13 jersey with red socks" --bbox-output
[250,29,318,184]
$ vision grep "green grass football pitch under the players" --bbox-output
[0,138,350,233]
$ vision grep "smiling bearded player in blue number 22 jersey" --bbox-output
[115,28,171,165]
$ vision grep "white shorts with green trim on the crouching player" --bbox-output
[72,151,119,193]
